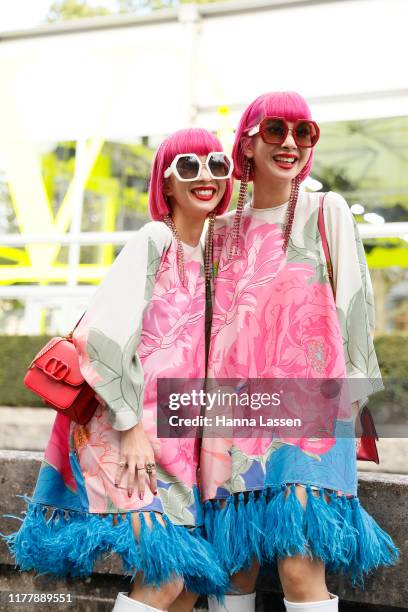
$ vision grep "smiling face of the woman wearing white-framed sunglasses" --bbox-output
[164,155,227,218]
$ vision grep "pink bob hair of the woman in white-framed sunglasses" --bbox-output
[149,128,232,221]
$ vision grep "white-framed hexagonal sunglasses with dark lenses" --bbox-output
[164,151,234,182]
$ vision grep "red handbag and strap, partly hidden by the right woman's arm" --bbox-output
[317,193,380,464]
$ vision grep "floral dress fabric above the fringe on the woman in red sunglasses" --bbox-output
[200,192,383,499]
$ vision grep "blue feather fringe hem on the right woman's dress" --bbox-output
[204,484,399,586]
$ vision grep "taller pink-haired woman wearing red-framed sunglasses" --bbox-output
[200,92,398,612]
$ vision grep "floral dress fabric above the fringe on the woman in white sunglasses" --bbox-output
[33,223,205,526]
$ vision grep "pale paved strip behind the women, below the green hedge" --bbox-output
[0,407,408,474]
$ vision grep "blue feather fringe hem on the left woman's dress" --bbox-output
[0,497,229,601]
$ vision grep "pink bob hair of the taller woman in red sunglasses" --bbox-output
[232,91,313,181]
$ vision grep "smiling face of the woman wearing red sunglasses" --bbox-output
[244,121,311,183]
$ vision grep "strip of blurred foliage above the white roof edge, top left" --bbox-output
[47,0,228,23]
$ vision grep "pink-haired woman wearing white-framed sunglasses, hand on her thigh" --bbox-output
[2,128,233,612]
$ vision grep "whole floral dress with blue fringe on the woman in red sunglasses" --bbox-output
[200,192,398,583]
